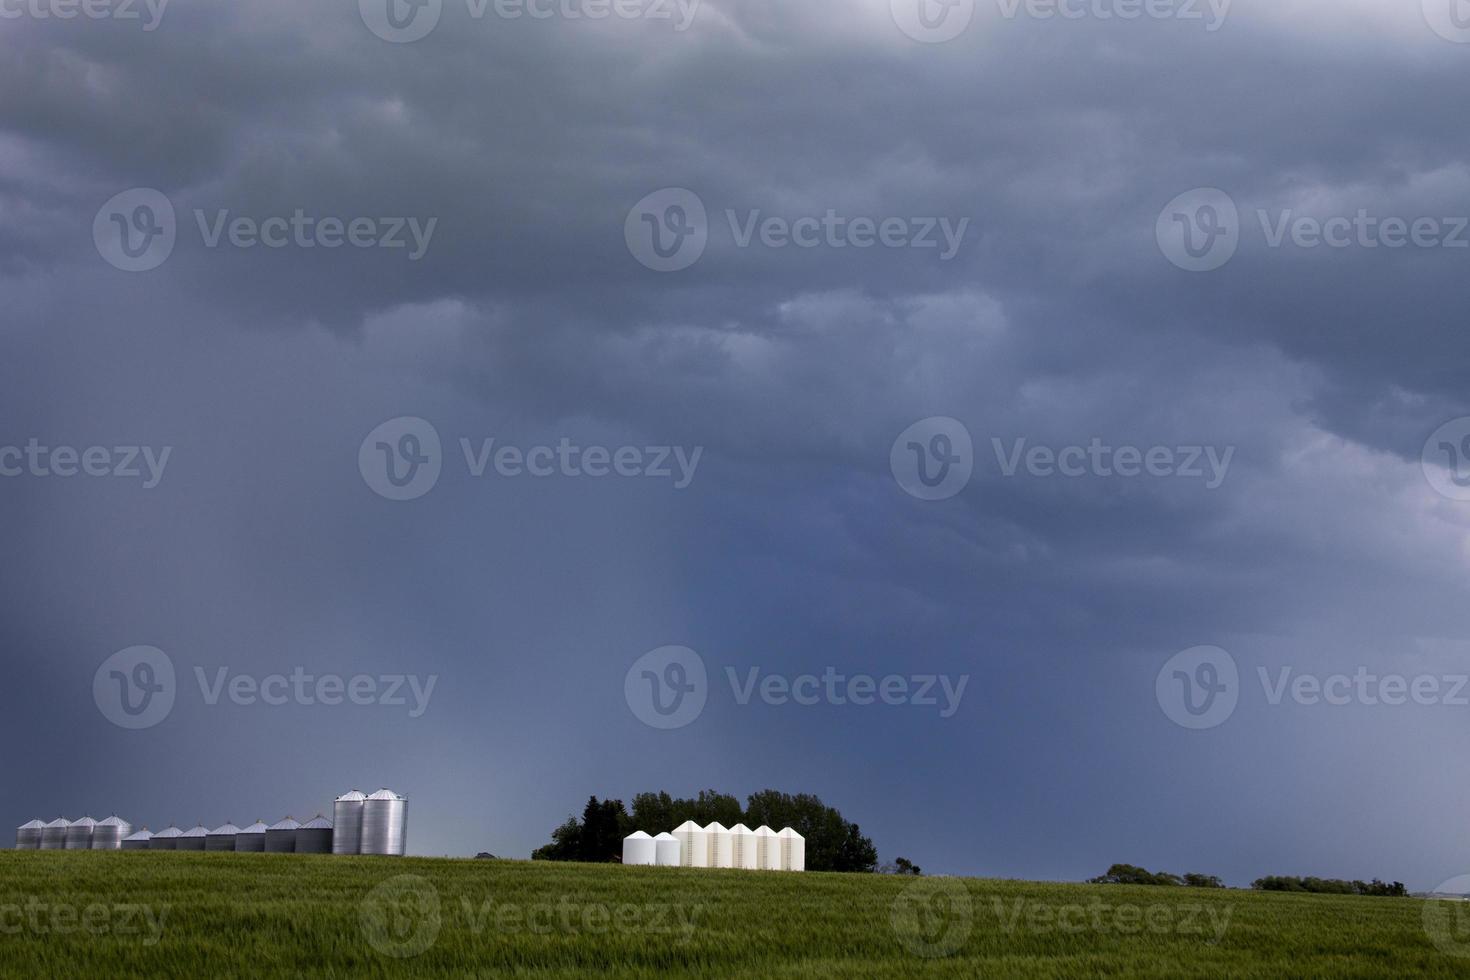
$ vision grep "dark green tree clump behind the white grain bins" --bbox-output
[531,789,878,873]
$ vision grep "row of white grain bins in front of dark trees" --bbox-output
[623,820,807,871]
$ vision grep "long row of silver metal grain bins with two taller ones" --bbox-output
[15,789,409,857]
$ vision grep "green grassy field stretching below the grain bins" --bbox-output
[0,852,1470,979]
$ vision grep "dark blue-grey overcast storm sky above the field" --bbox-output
[0,0,1470,889]
